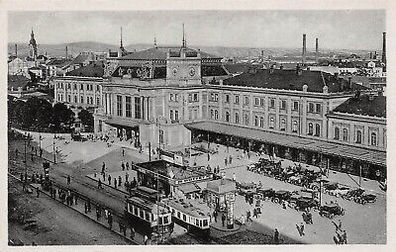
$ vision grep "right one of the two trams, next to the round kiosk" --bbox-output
[164,198,210,239]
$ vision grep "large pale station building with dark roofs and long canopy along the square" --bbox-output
[55,42,386,179]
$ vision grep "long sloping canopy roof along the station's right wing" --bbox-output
[185,122,386,166]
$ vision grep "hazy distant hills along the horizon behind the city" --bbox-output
[8,41,369,58]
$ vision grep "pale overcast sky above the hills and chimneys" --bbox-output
[8,10,385,49]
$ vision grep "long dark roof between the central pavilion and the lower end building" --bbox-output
[224,69,367,93]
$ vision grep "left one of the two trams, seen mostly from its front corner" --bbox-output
[125,193,174,237]
